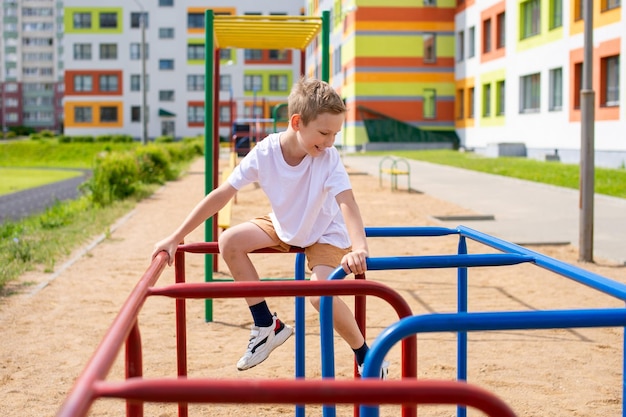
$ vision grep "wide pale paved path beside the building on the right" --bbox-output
[344,156,626,264]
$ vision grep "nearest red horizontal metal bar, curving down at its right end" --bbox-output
[96,379,515,417]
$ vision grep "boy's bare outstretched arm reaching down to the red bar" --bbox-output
[152,182,237,265]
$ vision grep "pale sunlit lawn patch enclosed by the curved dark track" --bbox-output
[0,167,82,195]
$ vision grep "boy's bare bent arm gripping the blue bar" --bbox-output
[336,190,369,274]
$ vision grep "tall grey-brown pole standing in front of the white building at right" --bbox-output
[578,0,595,262]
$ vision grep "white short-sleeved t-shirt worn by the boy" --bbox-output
[228,133,352,248]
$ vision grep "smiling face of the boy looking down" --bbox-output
[294,113,345,157]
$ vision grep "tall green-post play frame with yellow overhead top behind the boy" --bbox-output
[204,9,330,321]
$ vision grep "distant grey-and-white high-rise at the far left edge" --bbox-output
[0,0,63,130]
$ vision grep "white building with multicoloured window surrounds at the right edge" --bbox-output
[455,0,626,167]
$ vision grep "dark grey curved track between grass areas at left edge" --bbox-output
[0,168,89,224]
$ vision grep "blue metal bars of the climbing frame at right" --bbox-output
[320,226,626,417]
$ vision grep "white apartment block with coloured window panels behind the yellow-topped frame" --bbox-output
[64,0,302,140]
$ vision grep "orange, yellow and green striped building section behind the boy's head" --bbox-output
[307,0,456,149]
